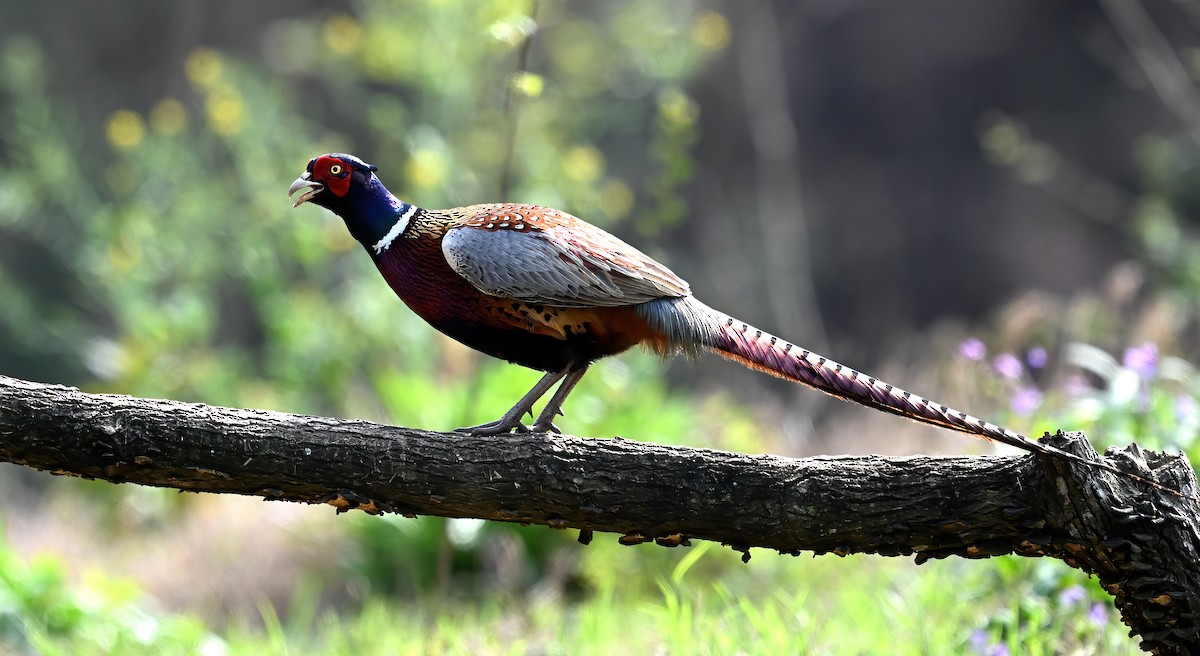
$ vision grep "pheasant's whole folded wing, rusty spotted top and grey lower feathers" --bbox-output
[442,204,690,307]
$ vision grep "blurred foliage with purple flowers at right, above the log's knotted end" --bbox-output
[959,106,1200,463]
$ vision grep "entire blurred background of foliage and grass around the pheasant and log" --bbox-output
[0,0,1200,654]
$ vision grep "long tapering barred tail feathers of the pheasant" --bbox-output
[709,311,1200,500]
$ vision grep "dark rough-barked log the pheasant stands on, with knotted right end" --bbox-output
[0,377,1200,654]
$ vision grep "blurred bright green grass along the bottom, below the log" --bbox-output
[0,536,1138,656]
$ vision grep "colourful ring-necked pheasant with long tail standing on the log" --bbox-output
[288,154,1180,494]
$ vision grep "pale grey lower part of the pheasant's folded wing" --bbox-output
[442,227,688,307]
